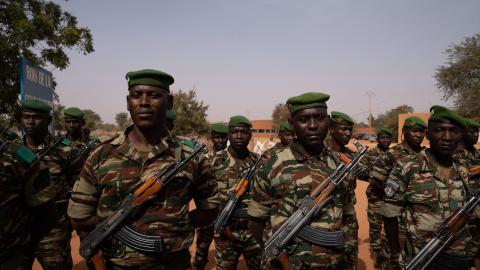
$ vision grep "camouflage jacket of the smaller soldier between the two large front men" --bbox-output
[212,147,257,211]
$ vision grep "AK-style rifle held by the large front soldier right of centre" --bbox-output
[265,141,368,269]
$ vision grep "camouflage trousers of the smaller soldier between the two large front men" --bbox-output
[214,224,263,270]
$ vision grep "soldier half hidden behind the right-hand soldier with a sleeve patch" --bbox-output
[369,116,427,269]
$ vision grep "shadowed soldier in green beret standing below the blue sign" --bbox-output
[17,100,83,269]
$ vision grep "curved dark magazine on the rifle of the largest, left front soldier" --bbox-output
[115,225,163,253]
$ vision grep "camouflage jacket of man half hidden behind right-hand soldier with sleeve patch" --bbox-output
[370,140,425,182]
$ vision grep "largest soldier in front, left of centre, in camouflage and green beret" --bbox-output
[68,69,218,269]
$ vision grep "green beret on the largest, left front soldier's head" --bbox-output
[125,69,174,91]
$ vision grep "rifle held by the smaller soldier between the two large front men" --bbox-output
[215,155,262,241]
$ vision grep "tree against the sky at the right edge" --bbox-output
[434,34,480,121]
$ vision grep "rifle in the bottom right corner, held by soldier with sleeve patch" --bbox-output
[406,192,480,270]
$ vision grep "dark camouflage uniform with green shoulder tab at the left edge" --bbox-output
[0,143,55,270]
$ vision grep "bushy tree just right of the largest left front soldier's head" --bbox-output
[172,86,210,137]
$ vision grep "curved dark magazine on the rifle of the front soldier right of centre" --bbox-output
[298,225,345,247]
